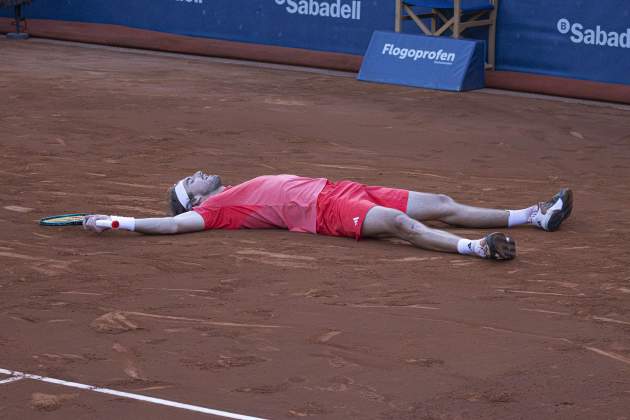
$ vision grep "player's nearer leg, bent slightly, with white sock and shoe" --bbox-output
[361,206,516,259]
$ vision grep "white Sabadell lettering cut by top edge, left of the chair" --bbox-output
[274,0,361,20]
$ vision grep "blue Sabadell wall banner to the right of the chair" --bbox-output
[497,0,630,84]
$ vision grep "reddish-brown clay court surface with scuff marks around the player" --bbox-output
[0,40,630,419]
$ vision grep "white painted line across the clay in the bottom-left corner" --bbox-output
[0,368,264,420]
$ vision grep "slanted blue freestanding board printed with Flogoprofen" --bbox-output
[359,31,485,91]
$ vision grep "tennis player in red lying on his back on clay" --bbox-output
[83,171,573,260]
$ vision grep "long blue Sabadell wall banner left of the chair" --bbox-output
[0,0,394,55]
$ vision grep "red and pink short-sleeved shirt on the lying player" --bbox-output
[193,175,327,233]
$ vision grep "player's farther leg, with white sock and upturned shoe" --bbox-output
[407,189,573,231]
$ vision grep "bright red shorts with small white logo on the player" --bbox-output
[316,181,409,240]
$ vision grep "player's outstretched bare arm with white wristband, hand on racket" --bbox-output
[83,211,204,235]
